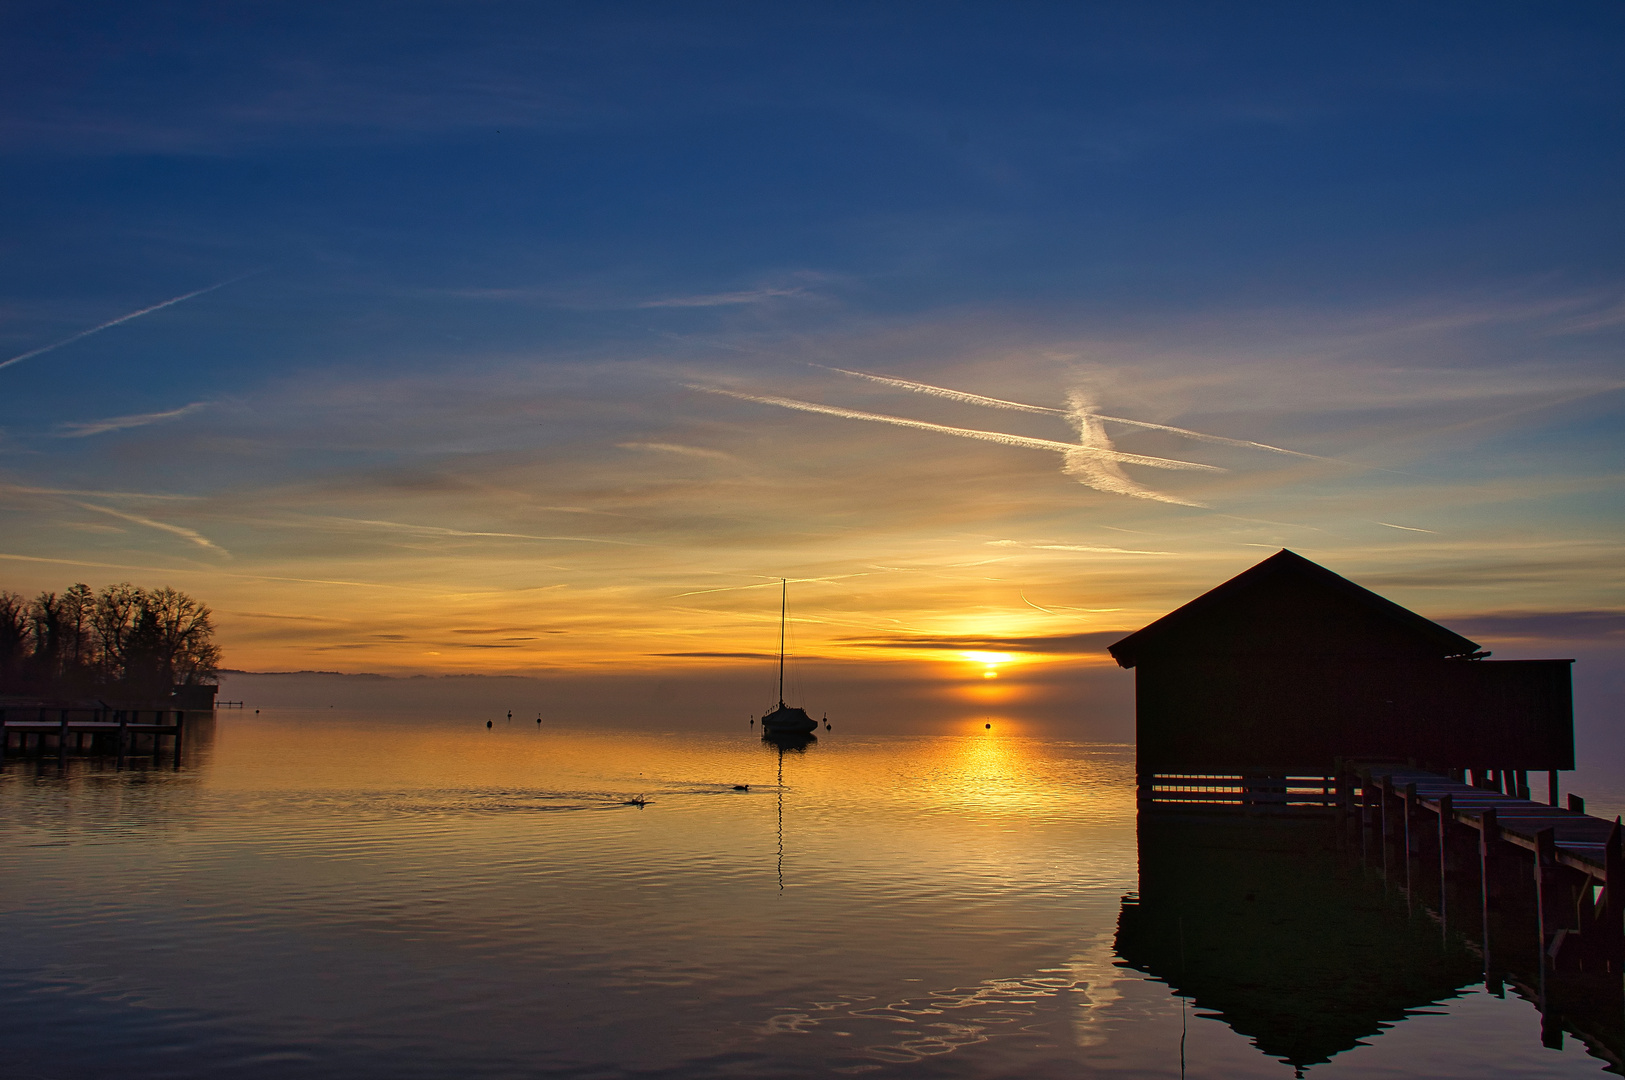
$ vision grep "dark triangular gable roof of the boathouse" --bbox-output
[1108,549,1479,667]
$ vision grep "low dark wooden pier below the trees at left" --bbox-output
[0,706,187,768]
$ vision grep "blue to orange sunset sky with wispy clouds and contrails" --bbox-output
[0,0,1625,704]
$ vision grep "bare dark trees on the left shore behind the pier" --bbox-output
[0,581,219,698]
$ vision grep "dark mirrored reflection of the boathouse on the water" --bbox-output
[1116,815,1484,1075]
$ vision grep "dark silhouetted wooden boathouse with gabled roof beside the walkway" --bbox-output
[1110,551,1575,802]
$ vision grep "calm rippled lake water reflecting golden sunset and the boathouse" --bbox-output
[0,710,1604,1080]
